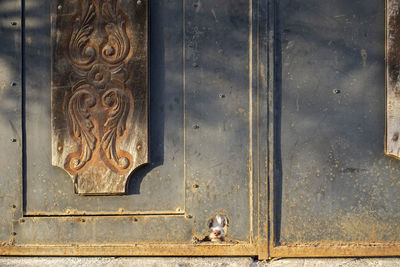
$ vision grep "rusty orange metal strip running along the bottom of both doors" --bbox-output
[0,243,400,260]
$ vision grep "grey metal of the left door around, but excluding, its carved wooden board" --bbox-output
[0,0,269,258]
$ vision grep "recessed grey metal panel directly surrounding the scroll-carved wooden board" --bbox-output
[25,1,185,216]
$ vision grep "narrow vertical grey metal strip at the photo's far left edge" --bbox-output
[0,0,24,246]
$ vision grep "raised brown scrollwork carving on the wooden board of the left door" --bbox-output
[67,0,133,171]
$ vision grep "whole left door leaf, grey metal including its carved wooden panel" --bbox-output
[0,0,273,258]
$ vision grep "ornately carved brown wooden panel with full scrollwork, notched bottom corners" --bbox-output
[51,0,148,195]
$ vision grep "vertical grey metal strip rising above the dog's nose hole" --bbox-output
[181,0,265,245]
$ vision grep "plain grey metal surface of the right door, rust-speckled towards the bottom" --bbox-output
[271,0,400,253]
